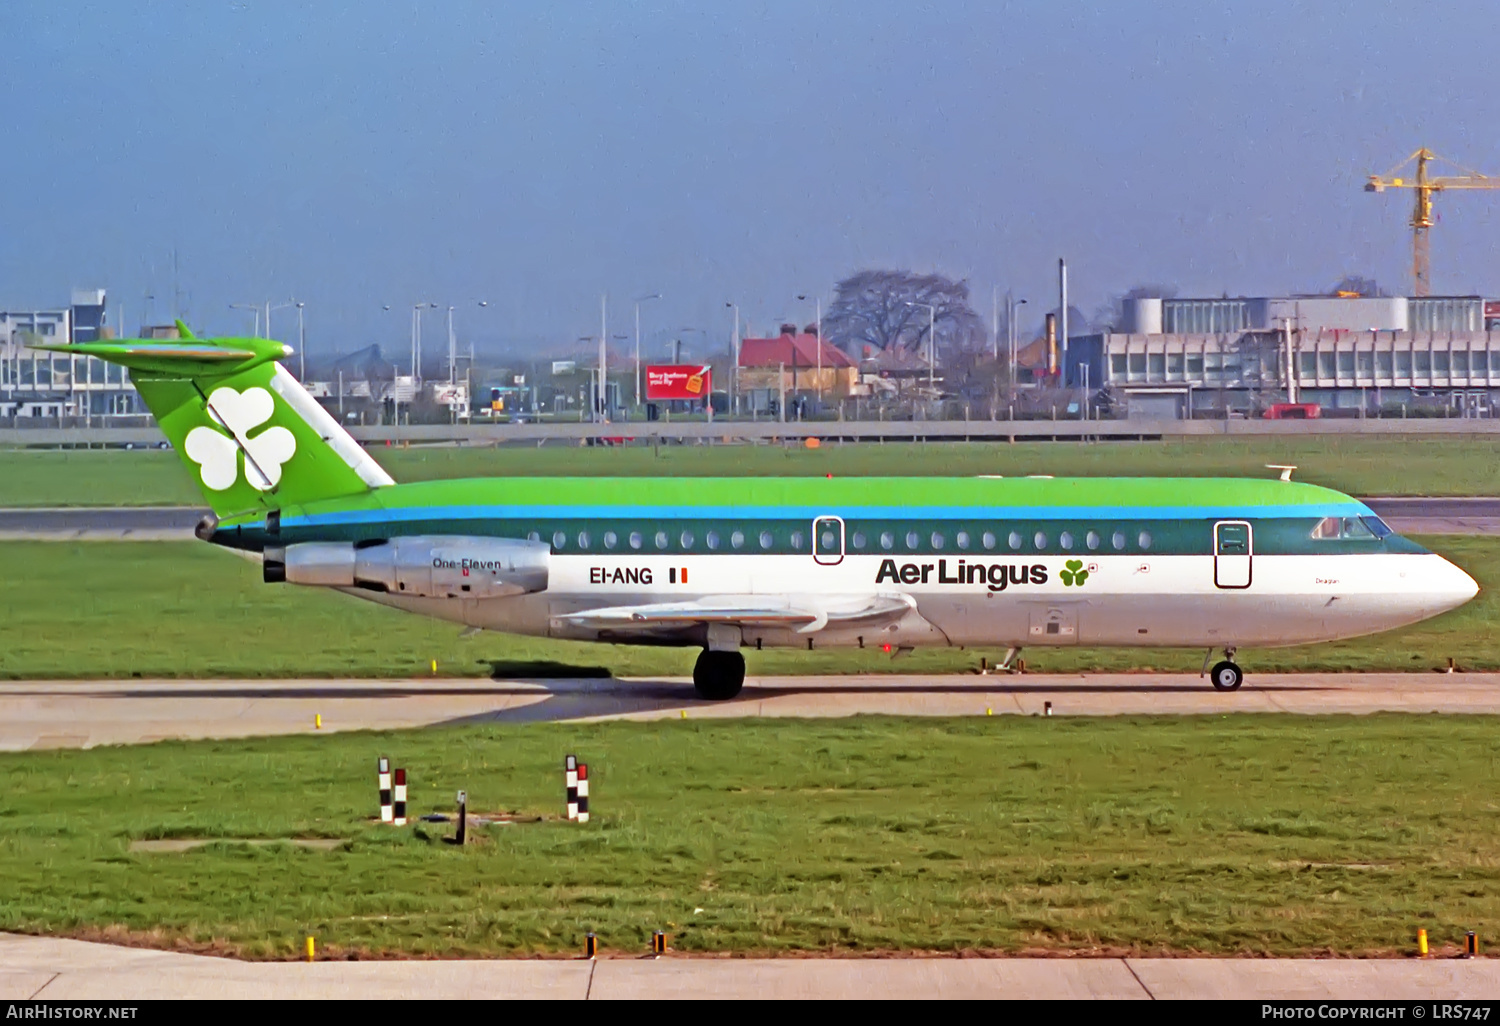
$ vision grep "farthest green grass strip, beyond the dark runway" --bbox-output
[0,437,1500,506]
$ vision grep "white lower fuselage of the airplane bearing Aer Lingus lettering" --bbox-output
[464,552,1454,647]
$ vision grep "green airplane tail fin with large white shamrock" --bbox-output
[35,333,395,518]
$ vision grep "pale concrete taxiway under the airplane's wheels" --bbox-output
[0,672,1500,752]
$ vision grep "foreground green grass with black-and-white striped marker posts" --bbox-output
[0,716,1500,959]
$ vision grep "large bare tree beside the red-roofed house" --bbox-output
[824,270,989,359]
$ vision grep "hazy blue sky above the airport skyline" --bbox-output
[0,0,1500,351]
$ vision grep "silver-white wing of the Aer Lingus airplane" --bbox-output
[554,594,917,635]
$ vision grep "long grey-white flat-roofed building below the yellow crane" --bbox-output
[1062,296,1500,419]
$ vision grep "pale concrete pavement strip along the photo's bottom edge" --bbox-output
[0,935,1500,1002]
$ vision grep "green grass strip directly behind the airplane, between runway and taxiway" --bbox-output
[0,537,1500,680]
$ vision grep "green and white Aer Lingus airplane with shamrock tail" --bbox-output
[36,321,1479,701]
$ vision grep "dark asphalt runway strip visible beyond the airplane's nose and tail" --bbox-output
[0,497,1500,542]
